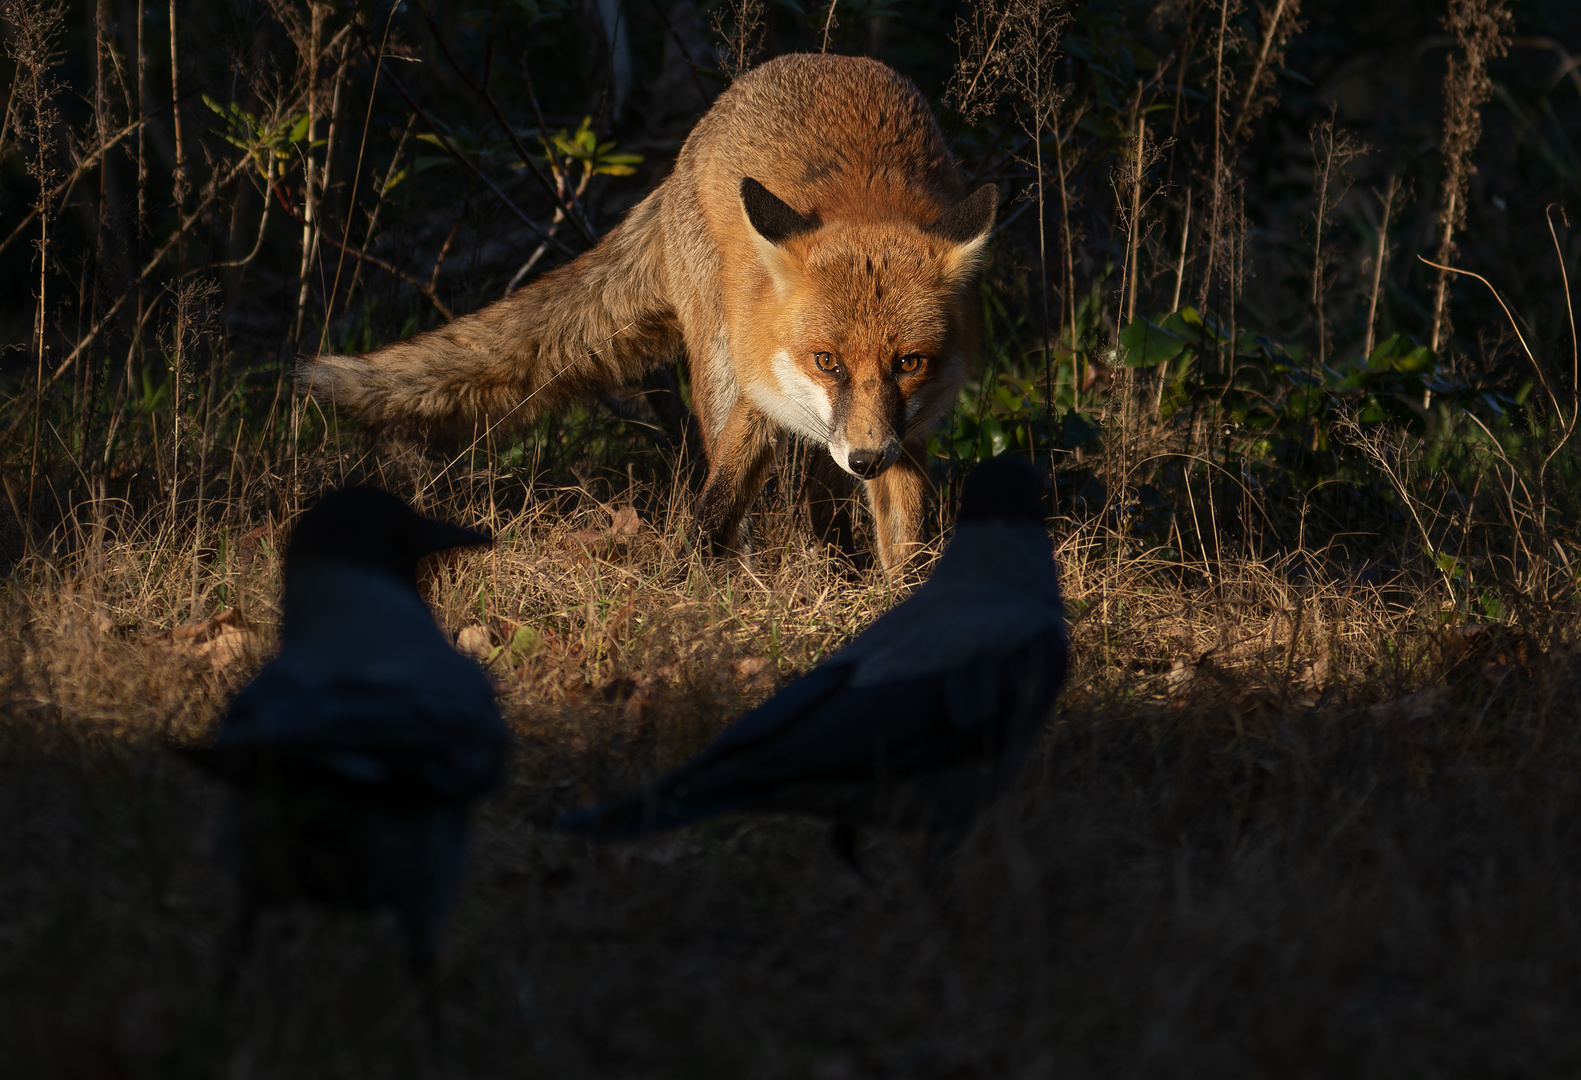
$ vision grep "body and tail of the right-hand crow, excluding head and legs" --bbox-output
[557,523,1066,836]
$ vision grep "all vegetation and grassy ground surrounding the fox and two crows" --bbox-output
[0,0,1581,1080]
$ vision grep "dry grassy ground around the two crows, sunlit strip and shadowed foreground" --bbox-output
[0,474,1581,1080]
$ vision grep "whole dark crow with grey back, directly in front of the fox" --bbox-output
[555,457,1067,859]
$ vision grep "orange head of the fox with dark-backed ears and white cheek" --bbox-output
[741,177,998,479]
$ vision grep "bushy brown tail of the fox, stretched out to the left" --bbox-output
[296,188,680,433]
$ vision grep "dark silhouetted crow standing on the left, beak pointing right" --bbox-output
[190,487,508,985]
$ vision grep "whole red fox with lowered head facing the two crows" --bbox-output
[299,55,998,569]
